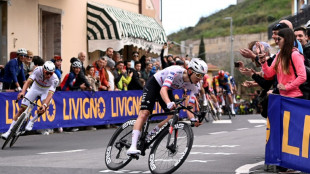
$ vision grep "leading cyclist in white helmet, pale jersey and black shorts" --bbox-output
[127,58,208,155]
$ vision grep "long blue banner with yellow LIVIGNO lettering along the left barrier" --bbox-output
[0,90,186,132]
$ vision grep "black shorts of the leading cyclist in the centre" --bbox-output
[140,76,175,113]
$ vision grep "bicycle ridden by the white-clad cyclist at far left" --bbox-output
[2,97,40,150]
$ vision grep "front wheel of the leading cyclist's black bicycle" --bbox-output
[148,122,194,174]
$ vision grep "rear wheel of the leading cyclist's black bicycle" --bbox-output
[105,120,136,170]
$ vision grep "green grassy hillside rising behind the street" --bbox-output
[168,0,291,41]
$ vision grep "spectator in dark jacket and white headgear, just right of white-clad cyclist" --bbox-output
[61,61,91,91]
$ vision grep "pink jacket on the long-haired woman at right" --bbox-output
[262,50,307,97]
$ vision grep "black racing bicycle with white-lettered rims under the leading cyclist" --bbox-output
[105,98,204,174]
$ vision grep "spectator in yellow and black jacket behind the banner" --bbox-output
[113,61,133,91]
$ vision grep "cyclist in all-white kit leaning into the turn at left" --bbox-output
[1,61,59,139]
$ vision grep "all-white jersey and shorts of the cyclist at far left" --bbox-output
[22,66,59,107]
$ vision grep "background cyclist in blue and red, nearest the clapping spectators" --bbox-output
[215,70,236,115]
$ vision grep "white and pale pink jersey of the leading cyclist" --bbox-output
[154,65,200,103]
